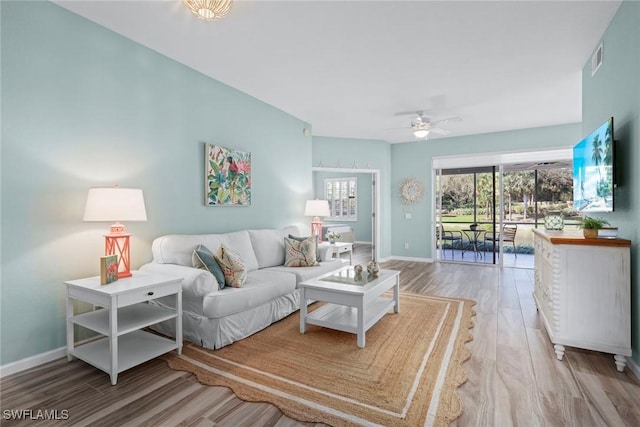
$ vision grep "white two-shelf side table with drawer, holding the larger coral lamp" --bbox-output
[65,271,182,385]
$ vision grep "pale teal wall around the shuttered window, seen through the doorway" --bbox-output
[313,171,373,242]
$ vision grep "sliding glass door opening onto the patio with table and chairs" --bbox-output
[434,161,579,268]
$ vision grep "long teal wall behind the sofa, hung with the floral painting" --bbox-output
[0,1,313,365]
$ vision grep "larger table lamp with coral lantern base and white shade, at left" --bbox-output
[83,185,147,278]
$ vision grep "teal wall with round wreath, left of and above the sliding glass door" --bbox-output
[391,124,581,259]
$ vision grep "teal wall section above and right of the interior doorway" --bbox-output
[313,136,392,259]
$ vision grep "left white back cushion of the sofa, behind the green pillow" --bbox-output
[151,230,258,271]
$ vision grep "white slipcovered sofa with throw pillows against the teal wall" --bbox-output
[140,226,343,348]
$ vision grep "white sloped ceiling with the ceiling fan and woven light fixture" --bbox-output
[55,0,620,143]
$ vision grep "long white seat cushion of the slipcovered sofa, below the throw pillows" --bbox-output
[203,270,296,318]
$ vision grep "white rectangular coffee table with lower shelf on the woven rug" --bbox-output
[299,266,400,348]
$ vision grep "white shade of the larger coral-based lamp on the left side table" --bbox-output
[83,187,147,222]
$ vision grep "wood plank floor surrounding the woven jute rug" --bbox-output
[0,261,640,427]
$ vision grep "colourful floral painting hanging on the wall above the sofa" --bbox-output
[204,144,251,206]
